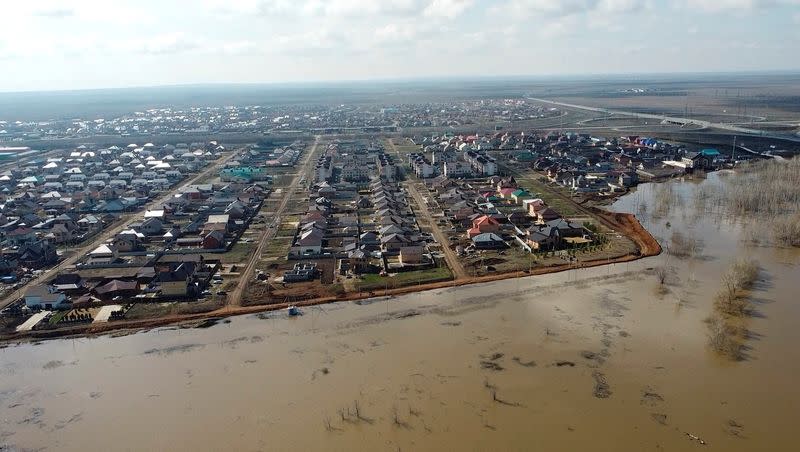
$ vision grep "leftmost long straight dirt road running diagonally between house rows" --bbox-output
[0,150,244,309]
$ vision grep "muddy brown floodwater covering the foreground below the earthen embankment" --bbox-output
[0,175,800,451]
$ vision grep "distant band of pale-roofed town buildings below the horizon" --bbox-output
[0,99,560,143]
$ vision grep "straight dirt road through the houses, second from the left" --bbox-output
[227,135,320,306]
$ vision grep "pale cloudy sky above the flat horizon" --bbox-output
[0,0,800,91]
